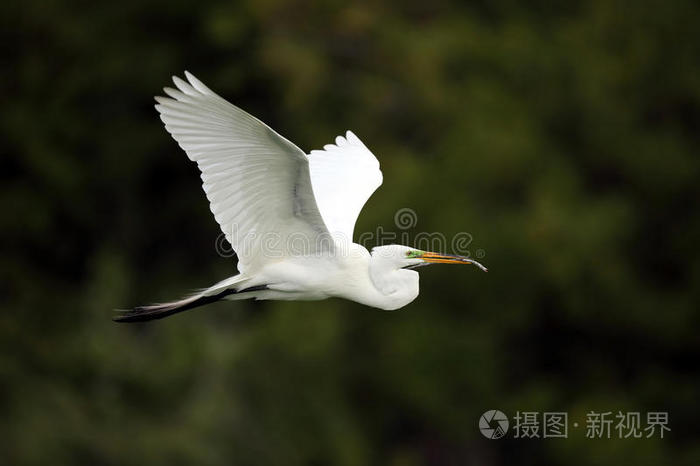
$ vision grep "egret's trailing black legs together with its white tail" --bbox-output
[113,275,267,322]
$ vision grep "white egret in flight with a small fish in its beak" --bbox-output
[114,71,486,322]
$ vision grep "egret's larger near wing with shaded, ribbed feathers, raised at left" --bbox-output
[156,72,332,272]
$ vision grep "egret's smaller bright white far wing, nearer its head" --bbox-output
[309,131,383,242]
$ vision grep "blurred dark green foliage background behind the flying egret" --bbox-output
[0,0,700,466]
